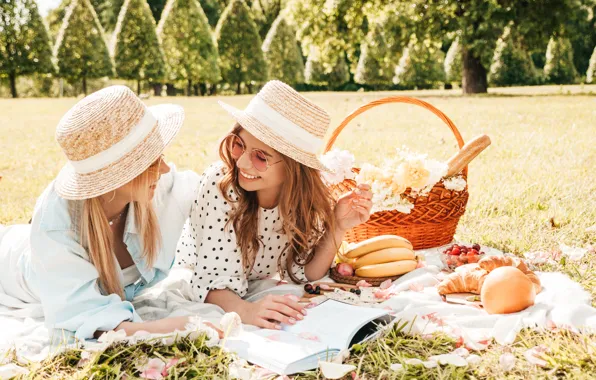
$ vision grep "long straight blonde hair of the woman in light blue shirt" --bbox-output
[81,165,161,299]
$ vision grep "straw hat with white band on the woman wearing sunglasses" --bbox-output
[219,80,330,171]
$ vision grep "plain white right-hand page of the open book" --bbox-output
[282,300,387,350]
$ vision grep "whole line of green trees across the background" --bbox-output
[0,0,596,97]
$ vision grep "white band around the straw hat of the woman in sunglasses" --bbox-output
[244,95,323,154]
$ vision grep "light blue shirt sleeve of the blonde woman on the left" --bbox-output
[27,223,142,339]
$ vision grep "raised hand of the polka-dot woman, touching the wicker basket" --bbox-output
[335,184,372,231]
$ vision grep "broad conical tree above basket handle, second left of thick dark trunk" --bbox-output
[393,37,445,88]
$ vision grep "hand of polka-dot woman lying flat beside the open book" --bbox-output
[241,295,306,330]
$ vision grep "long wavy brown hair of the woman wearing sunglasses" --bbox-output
[219,124,335,283]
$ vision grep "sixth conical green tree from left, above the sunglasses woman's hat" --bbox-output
[263,15,304,85]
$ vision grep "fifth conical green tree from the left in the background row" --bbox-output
[215,0,268,94]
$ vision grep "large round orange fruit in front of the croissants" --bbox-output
[480,267,536,314]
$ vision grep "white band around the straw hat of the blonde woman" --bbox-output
[68,108,157,174]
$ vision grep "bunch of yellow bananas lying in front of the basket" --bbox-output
[336,235,418,277]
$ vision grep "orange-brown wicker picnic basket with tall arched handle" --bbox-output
[325,96,469,249]
